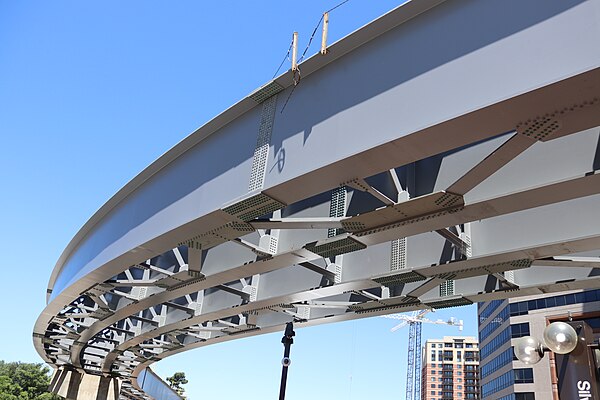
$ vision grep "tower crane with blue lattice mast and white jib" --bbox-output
[382,309,463,400]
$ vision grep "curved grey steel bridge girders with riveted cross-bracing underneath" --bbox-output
[34,0,600,398]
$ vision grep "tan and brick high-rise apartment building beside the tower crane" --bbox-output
[421,336,479,400]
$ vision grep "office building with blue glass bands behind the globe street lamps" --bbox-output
[478,290,600,400]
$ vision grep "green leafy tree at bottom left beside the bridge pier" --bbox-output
[0,361,60,400]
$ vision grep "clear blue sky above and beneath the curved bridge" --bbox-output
[0,0,477,399]
